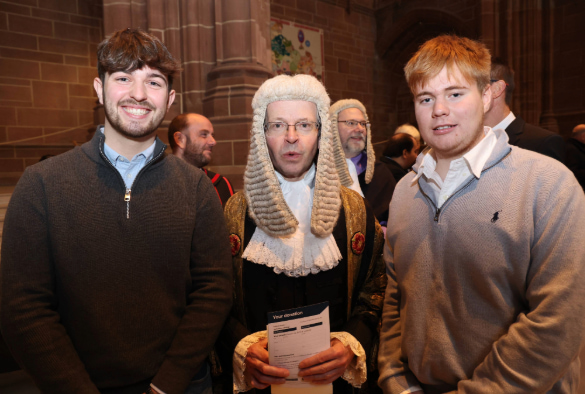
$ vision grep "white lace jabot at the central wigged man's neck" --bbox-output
[242,164,341,277]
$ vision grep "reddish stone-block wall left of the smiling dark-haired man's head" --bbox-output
[0,0,102,185]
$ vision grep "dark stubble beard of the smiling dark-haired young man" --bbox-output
[103,92,166,139]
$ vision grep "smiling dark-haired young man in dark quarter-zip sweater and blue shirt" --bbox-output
[0,29,232,394]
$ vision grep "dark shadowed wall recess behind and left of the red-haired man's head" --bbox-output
[374,0,481,142]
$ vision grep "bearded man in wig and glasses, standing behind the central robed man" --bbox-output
[329,99,396,226]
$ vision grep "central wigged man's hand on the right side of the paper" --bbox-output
[299,339,355,384]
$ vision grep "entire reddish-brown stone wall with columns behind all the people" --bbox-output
[0,0,585,188]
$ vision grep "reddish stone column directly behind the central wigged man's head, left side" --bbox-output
[203,0,272,188]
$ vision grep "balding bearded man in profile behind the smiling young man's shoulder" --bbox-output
[169,113,234,206]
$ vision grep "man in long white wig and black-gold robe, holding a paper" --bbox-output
[218,75,386,393]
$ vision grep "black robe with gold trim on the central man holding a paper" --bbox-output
[216,187,386,393]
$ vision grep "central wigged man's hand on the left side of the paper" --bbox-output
[244,339,289,389]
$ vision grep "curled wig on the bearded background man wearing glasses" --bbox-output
[329,99,376,187]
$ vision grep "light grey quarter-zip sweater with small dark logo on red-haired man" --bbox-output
[379,130,585,394]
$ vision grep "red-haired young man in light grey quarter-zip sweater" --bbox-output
[379,36,585,394]
